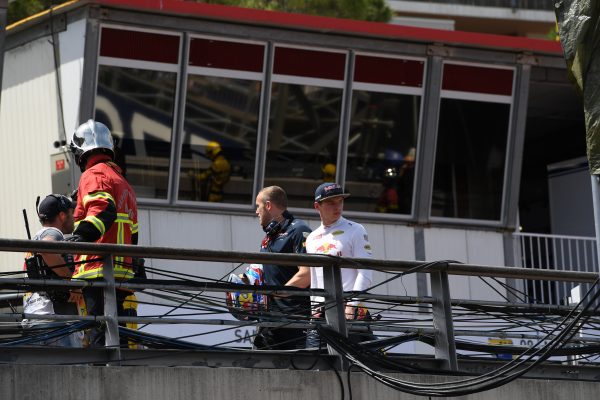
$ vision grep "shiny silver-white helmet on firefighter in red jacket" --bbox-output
[70,119,115,168]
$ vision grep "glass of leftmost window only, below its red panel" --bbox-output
[96,65,177,199]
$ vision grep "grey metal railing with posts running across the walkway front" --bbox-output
[0,239,598,371]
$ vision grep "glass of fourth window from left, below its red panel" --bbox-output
[344,91,421,214]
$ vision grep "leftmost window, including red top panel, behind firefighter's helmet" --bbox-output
[95,27,180,199]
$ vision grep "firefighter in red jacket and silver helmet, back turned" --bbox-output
[67,120,138,347]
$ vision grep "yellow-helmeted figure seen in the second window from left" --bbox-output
[188,140,231,202]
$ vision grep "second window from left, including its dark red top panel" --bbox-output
[178,38,265,204]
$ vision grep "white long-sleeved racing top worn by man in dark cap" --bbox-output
[306,217,373,305]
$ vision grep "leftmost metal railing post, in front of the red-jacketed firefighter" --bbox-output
[103,254,121,361]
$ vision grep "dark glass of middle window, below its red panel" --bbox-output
[265,83,343,208]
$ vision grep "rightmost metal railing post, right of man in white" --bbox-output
[430,271,458,371]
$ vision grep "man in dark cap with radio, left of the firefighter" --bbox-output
[23,194,81,347]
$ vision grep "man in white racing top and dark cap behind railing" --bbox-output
[306,182,373,347]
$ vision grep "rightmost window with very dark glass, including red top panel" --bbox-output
[431,63,514,221]
